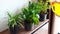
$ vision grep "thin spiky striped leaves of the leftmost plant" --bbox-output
[8,13,21,28]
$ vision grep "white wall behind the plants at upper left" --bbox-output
[0,0,29,32]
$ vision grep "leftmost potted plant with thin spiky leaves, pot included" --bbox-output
[8,13,21,34]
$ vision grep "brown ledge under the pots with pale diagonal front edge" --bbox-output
[0,19,49,34]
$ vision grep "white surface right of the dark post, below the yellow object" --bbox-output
[53,15,60,34]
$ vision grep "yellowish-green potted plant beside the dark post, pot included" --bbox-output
[39,0,49,21]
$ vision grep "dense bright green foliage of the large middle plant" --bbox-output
[22,2,40,24]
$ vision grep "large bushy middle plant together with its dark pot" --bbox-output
[22,2,39,31]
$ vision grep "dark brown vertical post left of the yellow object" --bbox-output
[48,9,54,34]
